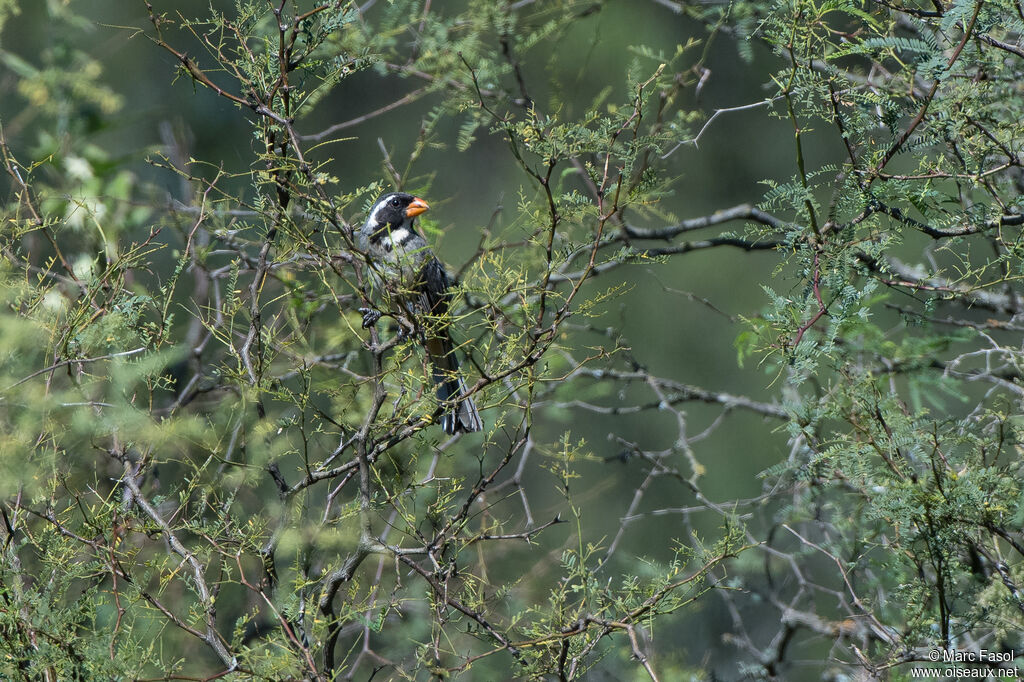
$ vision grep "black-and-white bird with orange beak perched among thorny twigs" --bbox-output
[357,191,483,435]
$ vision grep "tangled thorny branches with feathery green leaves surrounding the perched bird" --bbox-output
[8,0,1024,680]
